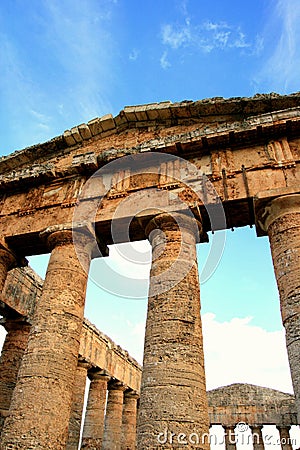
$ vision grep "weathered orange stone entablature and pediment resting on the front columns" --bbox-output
[0,93,300,255]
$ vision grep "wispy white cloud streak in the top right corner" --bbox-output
[253,0,300,93]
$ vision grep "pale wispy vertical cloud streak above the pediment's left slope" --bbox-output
[43,0,116,117]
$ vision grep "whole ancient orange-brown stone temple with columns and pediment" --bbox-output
[0,93,300,450]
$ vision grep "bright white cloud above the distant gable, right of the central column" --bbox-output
[202,313,292,392]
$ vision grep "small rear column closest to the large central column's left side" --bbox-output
[121,391,139,450]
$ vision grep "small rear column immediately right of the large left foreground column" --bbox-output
[66,360,90,450]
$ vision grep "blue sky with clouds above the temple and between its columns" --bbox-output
[0,0,300,391]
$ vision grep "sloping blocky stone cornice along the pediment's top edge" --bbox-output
[0,93,300,173]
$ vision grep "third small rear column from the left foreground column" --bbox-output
[102,382,126,450]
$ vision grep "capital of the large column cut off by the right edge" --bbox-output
[254,193,300,236]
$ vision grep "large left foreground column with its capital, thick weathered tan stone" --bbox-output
[0,227,91,450]
